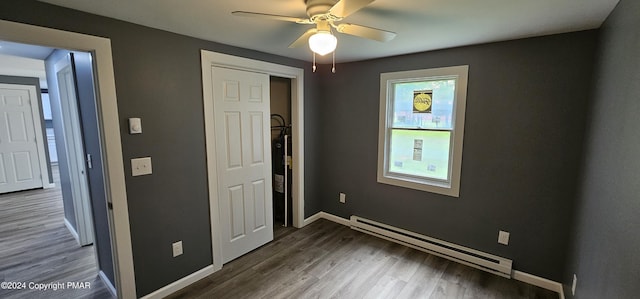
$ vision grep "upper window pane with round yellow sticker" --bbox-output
[392,79,456,129]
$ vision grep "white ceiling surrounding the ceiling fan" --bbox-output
[41,0,619,62]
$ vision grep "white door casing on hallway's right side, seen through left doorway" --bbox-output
[54,54,94,246]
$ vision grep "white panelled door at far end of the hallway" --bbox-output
[0,84,46,193]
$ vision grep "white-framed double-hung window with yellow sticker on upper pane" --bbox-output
[378,66,469,197]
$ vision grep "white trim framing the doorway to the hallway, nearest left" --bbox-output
[0,20,137,298]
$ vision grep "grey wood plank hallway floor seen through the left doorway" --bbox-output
[0,167,112,299]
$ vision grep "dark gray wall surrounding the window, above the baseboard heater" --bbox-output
[316,31,597,281]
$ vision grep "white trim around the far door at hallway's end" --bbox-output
[0,83,52,193]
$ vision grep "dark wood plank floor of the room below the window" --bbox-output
[169,220,558,299]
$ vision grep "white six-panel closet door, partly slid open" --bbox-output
[212,67,273,263]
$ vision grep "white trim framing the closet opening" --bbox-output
[200,50,304,270]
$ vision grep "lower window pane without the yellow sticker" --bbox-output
[389,129,451,180]
